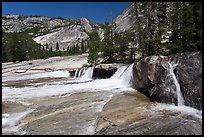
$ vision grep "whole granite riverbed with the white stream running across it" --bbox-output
[2,55,202,135]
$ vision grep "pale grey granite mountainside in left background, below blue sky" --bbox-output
[2,15,104,51]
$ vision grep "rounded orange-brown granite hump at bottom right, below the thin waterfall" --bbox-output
[95,92,202,135]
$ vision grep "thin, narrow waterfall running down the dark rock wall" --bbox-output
[168,62,184,106]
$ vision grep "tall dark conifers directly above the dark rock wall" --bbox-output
[131,2,202,56]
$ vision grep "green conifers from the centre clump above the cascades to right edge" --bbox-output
[88,2,202,64]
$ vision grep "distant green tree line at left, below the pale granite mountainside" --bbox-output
[2,31,87,62]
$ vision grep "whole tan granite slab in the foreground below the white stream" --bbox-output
[3,91,202,135]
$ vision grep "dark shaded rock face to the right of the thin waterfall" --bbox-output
[174,52,202,109]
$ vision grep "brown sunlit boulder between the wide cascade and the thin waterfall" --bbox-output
[133,56,177,103]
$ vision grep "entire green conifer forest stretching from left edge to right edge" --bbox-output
[2,2,202,64]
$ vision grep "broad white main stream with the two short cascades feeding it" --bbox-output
[2,64,133,101]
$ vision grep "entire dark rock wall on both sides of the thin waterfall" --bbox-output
[133,52,202,109]
